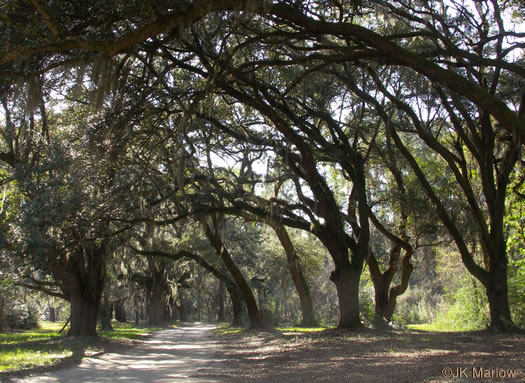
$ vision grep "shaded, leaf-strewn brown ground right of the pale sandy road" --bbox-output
[214,331,525,383]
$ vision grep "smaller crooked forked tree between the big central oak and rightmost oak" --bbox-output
[367,127,444,324]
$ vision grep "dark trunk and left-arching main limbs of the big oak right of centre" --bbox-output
[217,68,370,328]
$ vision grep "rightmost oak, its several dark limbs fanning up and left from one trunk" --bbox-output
[346,60,521,330]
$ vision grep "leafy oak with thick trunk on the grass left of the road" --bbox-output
[4,67,146,336]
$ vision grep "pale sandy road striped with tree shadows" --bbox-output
[9,324,225,383]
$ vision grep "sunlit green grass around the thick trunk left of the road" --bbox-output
[0,322,164,372]
